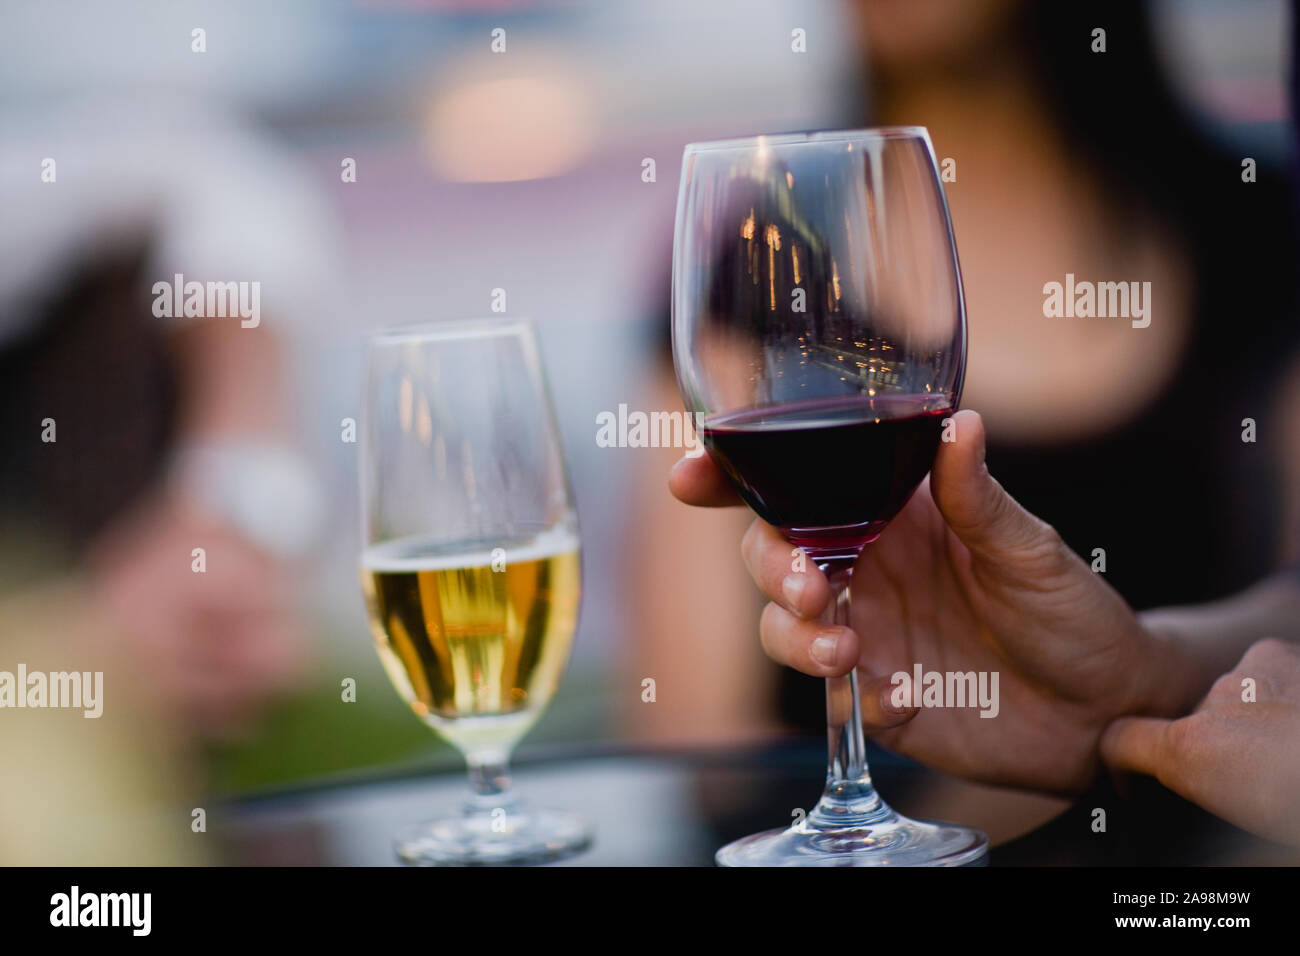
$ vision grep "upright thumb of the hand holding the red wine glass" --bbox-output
[930,408,1060,559]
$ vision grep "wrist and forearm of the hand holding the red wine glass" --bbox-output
[1139,568,1300,717]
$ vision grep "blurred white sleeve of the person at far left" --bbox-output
[0,99,339,345]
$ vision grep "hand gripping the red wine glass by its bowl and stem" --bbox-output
[671,411,1203,792]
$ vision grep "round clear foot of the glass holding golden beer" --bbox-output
[394,806,592,866]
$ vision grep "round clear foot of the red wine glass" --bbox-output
[715,805,988,866]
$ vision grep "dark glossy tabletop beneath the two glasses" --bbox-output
[218,740,1300,866]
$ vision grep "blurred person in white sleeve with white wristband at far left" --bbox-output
[0,98,330,862]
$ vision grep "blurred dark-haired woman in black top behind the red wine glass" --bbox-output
[629,0,1300,853]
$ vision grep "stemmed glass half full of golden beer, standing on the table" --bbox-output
[361,320,592,865]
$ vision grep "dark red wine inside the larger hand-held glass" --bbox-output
[701,394,952,561]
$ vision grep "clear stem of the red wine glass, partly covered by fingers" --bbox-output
[809,563,889,827]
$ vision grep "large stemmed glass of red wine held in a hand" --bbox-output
[672,126,988,866]
